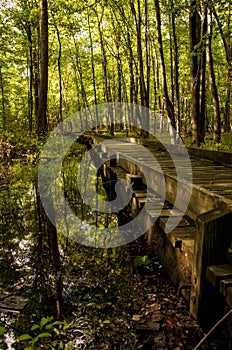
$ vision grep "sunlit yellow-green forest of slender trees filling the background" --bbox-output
[0,0,232,144]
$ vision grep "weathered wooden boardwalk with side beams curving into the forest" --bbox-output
[89,136,232,322]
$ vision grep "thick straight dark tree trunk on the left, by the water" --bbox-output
[37,0,48,135]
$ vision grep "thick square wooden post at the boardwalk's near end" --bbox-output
[190,207,232,325]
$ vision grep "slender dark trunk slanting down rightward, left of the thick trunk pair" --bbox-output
[155,0,176,130]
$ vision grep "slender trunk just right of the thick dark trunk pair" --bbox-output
[207,13,221,143]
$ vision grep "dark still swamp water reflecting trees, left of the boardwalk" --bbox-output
[0,144,144,349]
